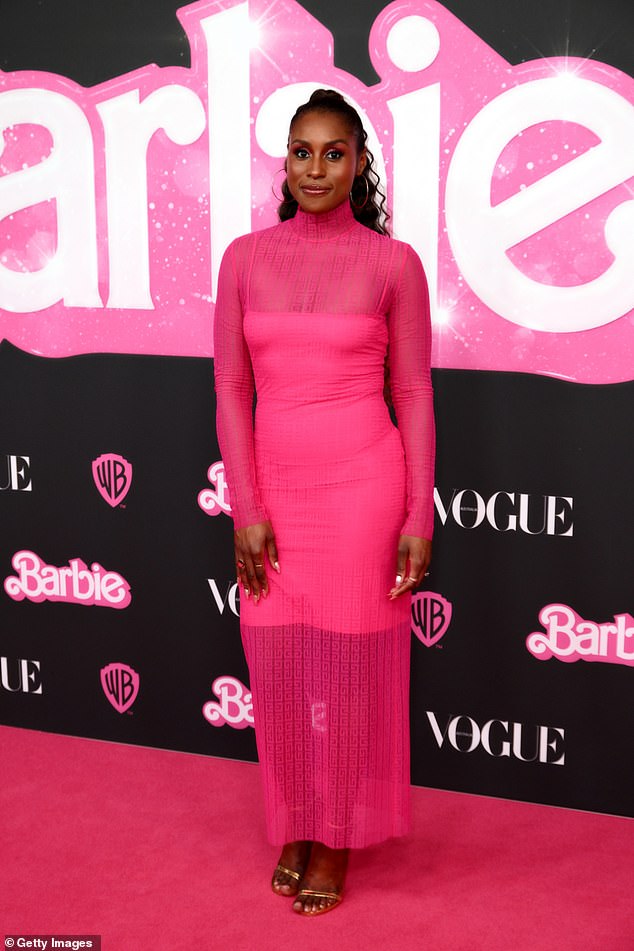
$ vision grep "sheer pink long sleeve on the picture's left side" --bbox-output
[214,242,268,529]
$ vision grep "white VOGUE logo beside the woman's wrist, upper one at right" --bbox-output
[434,488,573,536]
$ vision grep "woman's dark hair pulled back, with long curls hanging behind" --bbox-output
[277,89,390,234]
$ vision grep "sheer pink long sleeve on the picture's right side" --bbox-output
[388,245,435,539]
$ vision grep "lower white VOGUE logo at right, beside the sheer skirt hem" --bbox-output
[427,710,565,766]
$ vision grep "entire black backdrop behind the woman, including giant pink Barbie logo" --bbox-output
[0,0,634,815]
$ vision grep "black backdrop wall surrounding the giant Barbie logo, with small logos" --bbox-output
[0,0,634,815]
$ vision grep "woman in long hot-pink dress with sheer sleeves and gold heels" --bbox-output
[215,90,434,915]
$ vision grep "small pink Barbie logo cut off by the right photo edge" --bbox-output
[526,604,634,667]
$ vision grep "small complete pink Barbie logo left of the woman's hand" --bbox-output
[4,551,132,609]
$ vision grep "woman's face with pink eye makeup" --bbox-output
[286,111,366,214]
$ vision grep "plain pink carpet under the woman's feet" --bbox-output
[0,727,634,951]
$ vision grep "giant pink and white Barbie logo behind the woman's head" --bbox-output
[0,0,634,383]
